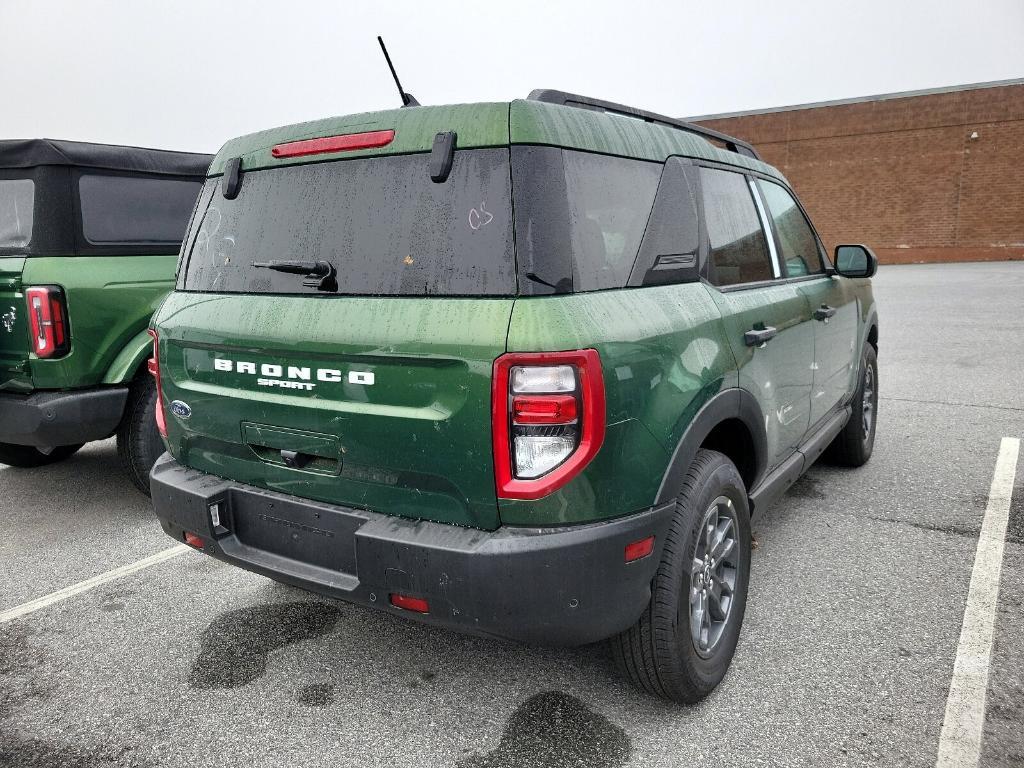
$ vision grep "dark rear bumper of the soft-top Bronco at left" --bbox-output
[0,387,128,447]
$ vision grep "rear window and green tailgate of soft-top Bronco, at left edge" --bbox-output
[0,178,35,391]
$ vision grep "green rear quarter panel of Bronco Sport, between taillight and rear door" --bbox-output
[500,283,736,525]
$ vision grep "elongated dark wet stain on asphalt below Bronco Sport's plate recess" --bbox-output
[188,602,341,689]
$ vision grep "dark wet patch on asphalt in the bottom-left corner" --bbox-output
[0,623,144,768]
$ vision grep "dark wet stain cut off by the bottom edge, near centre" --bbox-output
[459,691,633,768]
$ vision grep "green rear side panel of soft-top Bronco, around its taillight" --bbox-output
[24,254,177,389]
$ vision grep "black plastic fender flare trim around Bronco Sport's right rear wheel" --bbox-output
[654,388,768,505]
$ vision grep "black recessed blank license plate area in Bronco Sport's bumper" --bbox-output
[229,489,367,575]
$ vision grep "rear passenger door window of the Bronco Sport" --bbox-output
[700,168,775,286]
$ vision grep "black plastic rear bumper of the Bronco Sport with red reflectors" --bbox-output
[151,454,675,645]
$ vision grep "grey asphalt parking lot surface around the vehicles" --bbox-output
[0,262,1024,768]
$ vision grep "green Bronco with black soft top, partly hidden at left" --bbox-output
[0,139,211,493]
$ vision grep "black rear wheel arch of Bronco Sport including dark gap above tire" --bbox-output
[655,389,768,504]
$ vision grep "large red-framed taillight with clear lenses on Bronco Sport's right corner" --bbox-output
[492,349,605,499]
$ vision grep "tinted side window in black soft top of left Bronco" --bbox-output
[78,174,201,245]
